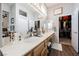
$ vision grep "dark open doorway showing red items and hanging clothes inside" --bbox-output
[59,15,71,45]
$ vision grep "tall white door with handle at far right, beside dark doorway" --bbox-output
[72,4,79,52]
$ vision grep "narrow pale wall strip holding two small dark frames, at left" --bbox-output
[9,3,16,32]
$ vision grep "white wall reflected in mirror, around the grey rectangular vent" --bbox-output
[15,3,46,32]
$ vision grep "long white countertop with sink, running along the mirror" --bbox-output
[0,31,54,56]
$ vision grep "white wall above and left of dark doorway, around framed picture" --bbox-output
[48,3,73,42]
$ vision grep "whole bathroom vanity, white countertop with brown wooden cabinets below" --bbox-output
[1,31,54,56]
